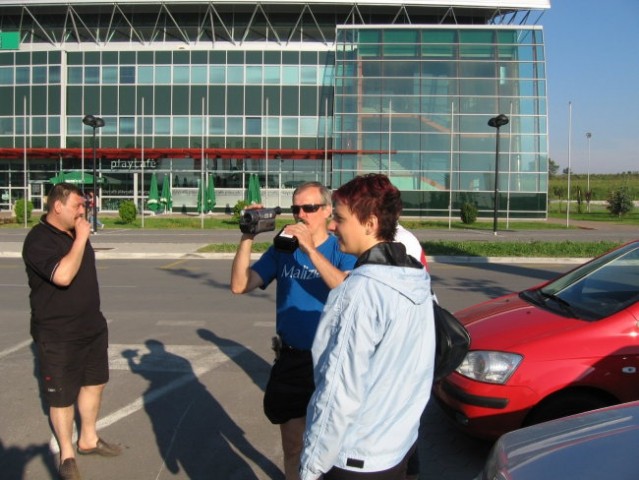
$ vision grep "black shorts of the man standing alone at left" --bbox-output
[36,328,109,408]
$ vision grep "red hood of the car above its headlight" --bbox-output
[455,293,585,350]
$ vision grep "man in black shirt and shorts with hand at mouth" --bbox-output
[22,183,121,479]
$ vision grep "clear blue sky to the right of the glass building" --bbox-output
[538,0,639,173]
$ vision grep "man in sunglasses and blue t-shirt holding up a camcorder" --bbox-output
[231,182,356,480]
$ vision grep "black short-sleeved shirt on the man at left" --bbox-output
[22,217,106,342]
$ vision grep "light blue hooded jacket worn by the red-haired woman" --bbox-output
[300,256,435,480]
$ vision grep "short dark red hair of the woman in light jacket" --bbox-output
[333,173,403,242]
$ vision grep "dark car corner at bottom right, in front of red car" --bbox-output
[476,402,639,480]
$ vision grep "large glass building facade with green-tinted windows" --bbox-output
[0,4,548,218]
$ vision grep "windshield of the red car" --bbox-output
[525,242,639,320]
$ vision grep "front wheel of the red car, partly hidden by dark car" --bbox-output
[523,392,616,426]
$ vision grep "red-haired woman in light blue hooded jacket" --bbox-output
[300,174,435,480]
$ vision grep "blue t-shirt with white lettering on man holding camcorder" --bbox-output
[251,235,357,350]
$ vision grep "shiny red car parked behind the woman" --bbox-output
[434,240,639,439]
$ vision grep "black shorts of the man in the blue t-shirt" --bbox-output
[264,347,315,425]
